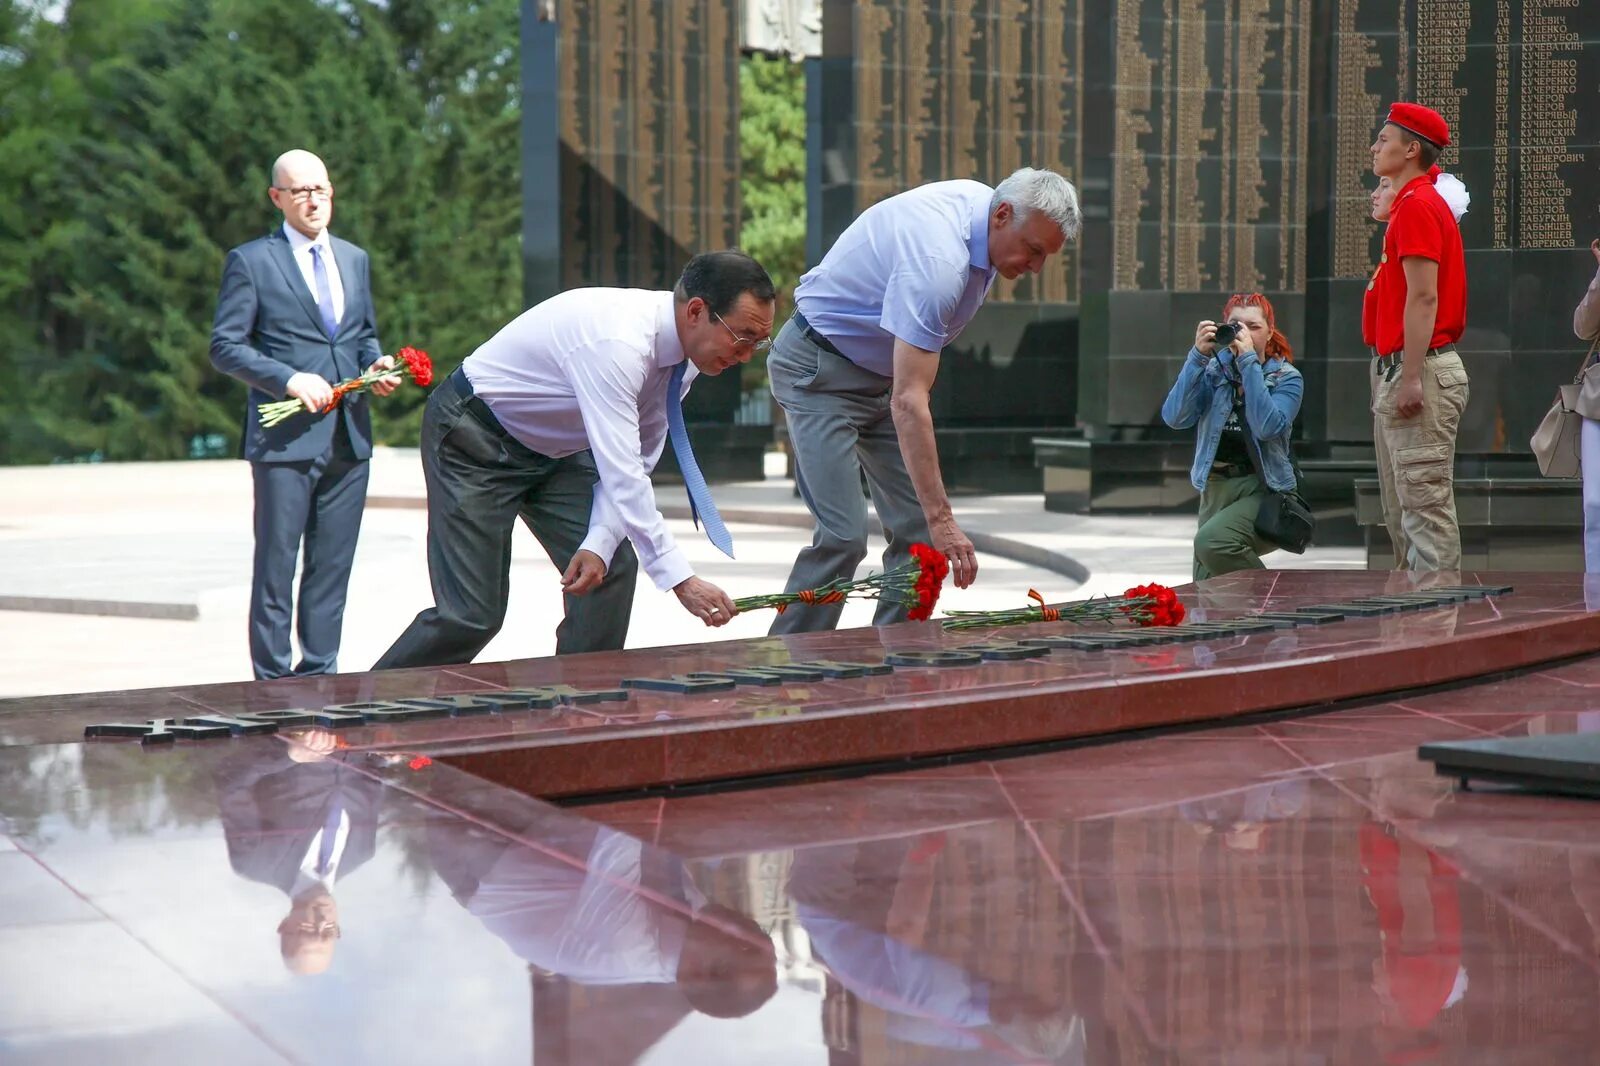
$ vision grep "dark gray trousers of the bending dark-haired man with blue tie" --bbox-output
[373,379,638,671]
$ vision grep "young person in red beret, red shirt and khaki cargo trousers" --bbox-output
[1363,104,1469,571]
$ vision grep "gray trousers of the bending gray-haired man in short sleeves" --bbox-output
[766,322,928,635]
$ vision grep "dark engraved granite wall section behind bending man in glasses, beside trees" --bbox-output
[522,0,752,479]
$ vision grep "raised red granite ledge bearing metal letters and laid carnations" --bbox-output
[0,571,1600,797]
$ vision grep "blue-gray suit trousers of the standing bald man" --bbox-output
[250,427,368,680]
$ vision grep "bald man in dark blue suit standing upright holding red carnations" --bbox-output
[211,149,398,680]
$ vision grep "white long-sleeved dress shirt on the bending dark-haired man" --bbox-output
[462,288,698,591]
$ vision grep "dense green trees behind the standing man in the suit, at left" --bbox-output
[0,0,520,463]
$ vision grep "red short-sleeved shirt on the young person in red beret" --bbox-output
[1363,174,1467,355]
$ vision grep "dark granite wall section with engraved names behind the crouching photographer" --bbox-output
[1078,0,1312,437]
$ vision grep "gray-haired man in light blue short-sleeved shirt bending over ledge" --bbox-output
[766,166,1080,634]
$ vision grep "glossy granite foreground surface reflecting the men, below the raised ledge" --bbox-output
[0,627,1600,1066]
